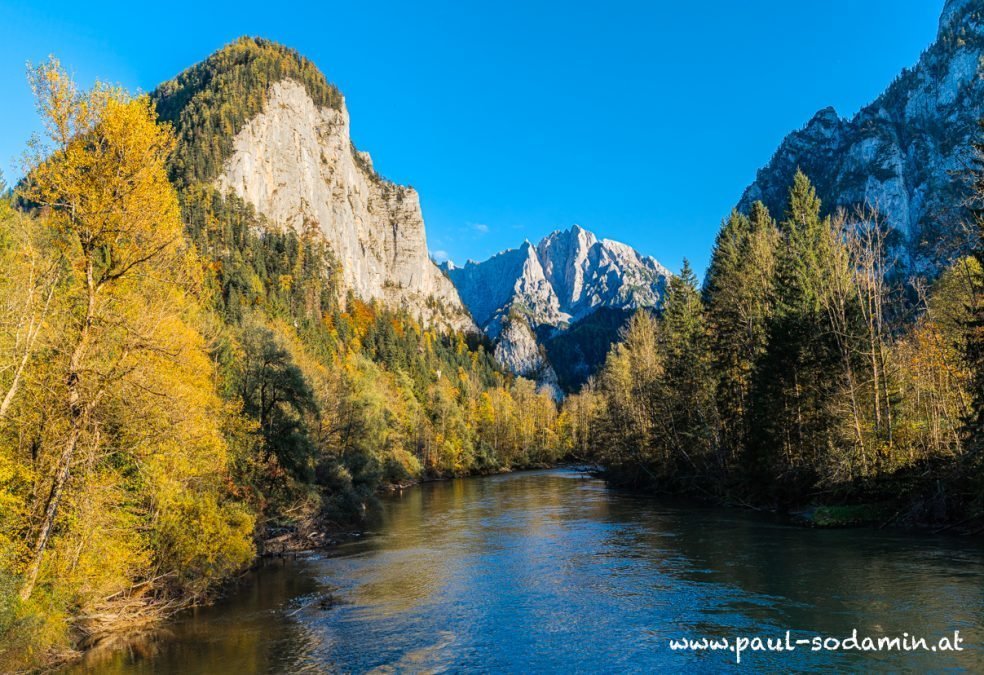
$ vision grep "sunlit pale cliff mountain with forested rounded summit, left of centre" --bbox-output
[153,38,474,330]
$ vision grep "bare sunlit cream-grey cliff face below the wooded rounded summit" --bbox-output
[217,80,474,330]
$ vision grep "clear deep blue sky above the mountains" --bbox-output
[0,0,943,271]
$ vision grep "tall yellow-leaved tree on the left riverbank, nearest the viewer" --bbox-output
[10,60,252,616]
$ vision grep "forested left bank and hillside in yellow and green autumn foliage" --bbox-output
[0,48,562,670]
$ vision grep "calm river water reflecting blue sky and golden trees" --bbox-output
[75,470,984,675]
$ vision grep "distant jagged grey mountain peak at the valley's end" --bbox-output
[444,225,670,389]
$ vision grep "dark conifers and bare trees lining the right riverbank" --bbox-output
[565,163,984,529]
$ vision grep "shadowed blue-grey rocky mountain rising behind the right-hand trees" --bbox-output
[739,0,984,264]
